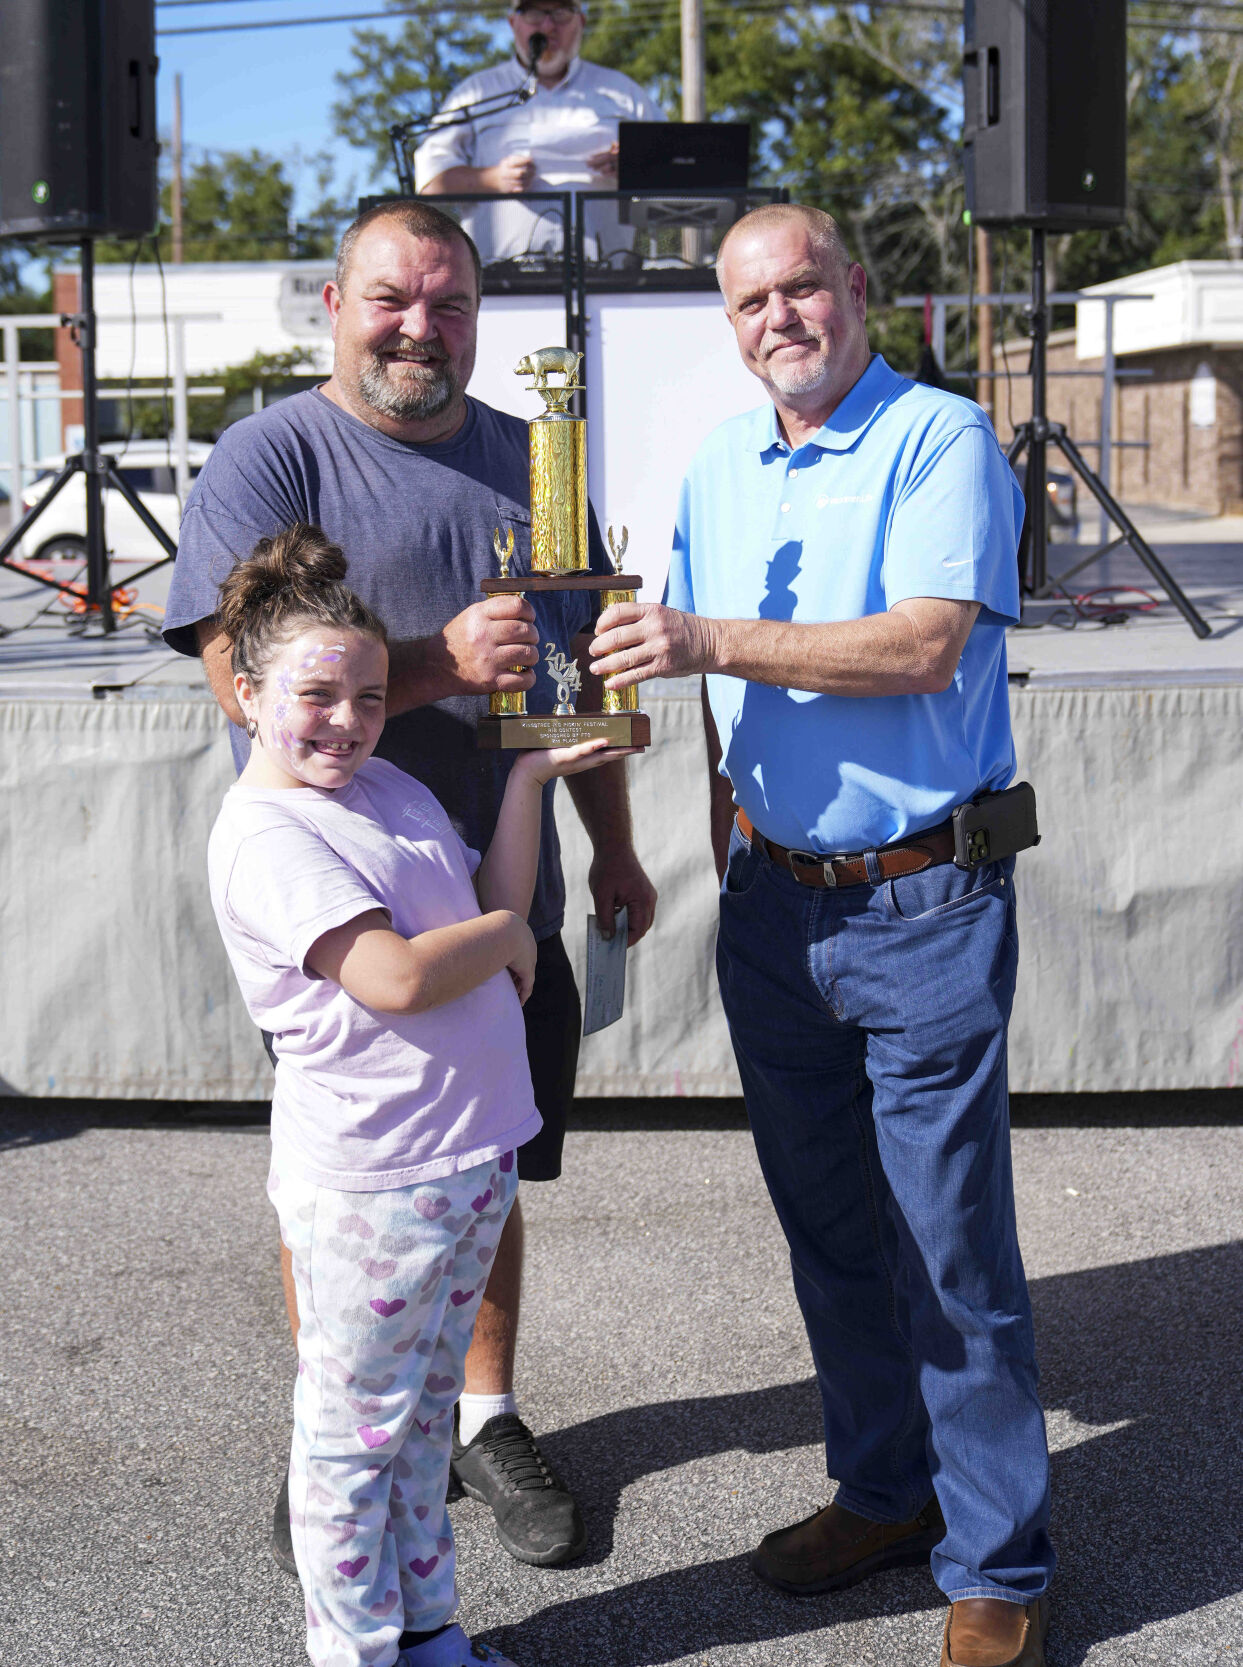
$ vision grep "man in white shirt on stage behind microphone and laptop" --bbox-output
[415,0,665,262]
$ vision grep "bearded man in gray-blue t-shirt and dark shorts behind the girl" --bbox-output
[165,202,656,1580]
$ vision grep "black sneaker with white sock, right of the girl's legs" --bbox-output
[452,1412,587,1569]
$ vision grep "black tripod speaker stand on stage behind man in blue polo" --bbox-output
[1006,227,1213,637]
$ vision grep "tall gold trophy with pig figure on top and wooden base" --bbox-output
[478,347,651,750]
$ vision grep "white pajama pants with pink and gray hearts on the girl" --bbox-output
[268,1152,518,1667]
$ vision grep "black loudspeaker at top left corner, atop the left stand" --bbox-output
[0,0,160,242]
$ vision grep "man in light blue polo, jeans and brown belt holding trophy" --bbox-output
[592,205,1053,1667]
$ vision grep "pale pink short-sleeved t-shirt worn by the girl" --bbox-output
[208,758,540,1192]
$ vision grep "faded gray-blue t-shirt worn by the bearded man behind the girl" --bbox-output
[163,388,596,940]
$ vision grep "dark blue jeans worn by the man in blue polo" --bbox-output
[716,827,1053,1604]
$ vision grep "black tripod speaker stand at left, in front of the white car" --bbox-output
[0,237,177,637]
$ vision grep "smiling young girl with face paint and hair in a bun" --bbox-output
[208,527,618,1667]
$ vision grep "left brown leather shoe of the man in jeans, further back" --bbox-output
[751,1499,945,1597]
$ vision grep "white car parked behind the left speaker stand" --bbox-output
[20,440,212,562]
